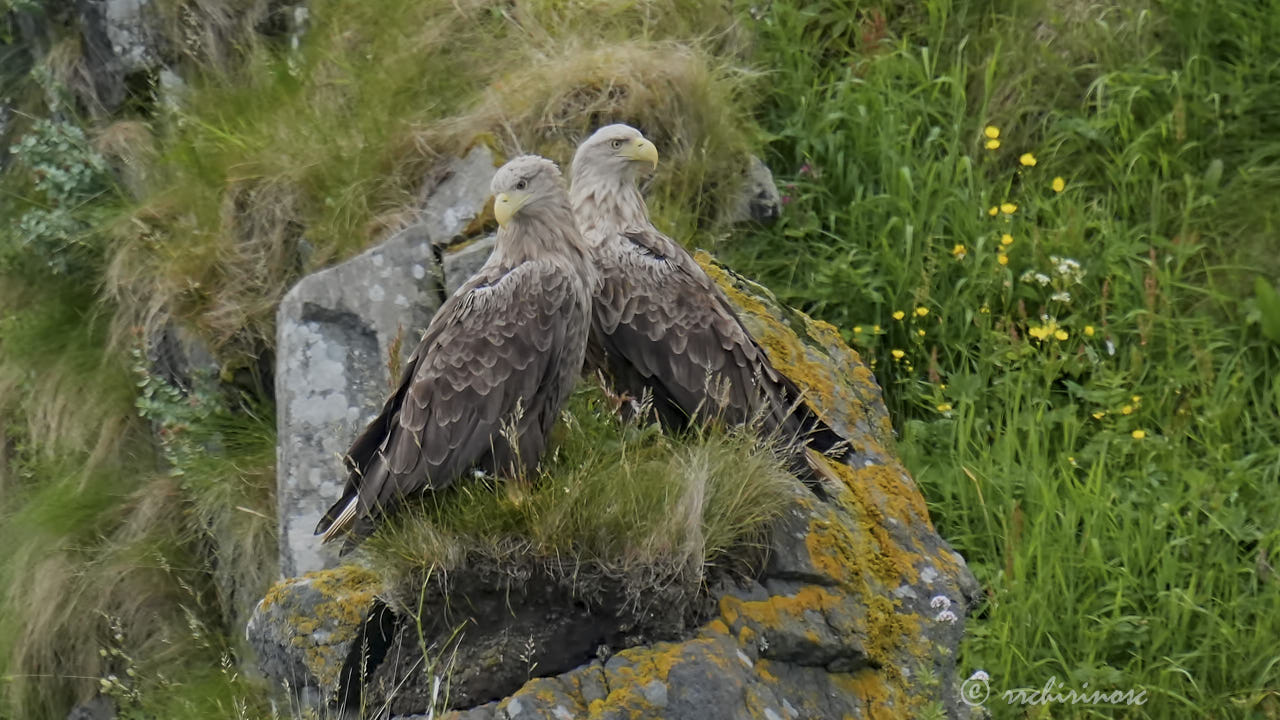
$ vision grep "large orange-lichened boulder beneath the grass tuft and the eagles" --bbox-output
[255,255,977,720]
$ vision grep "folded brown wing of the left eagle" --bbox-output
[316,260,586,541]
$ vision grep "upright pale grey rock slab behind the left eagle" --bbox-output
[275,225,439,577]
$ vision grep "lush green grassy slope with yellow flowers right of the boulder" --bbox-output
[731,0,1280,717]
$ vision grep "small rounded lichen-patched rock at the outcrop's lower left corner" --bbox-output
[246,565,379,706]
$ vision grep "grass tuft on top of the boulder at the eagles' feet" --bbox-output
[361,384,795,607]
